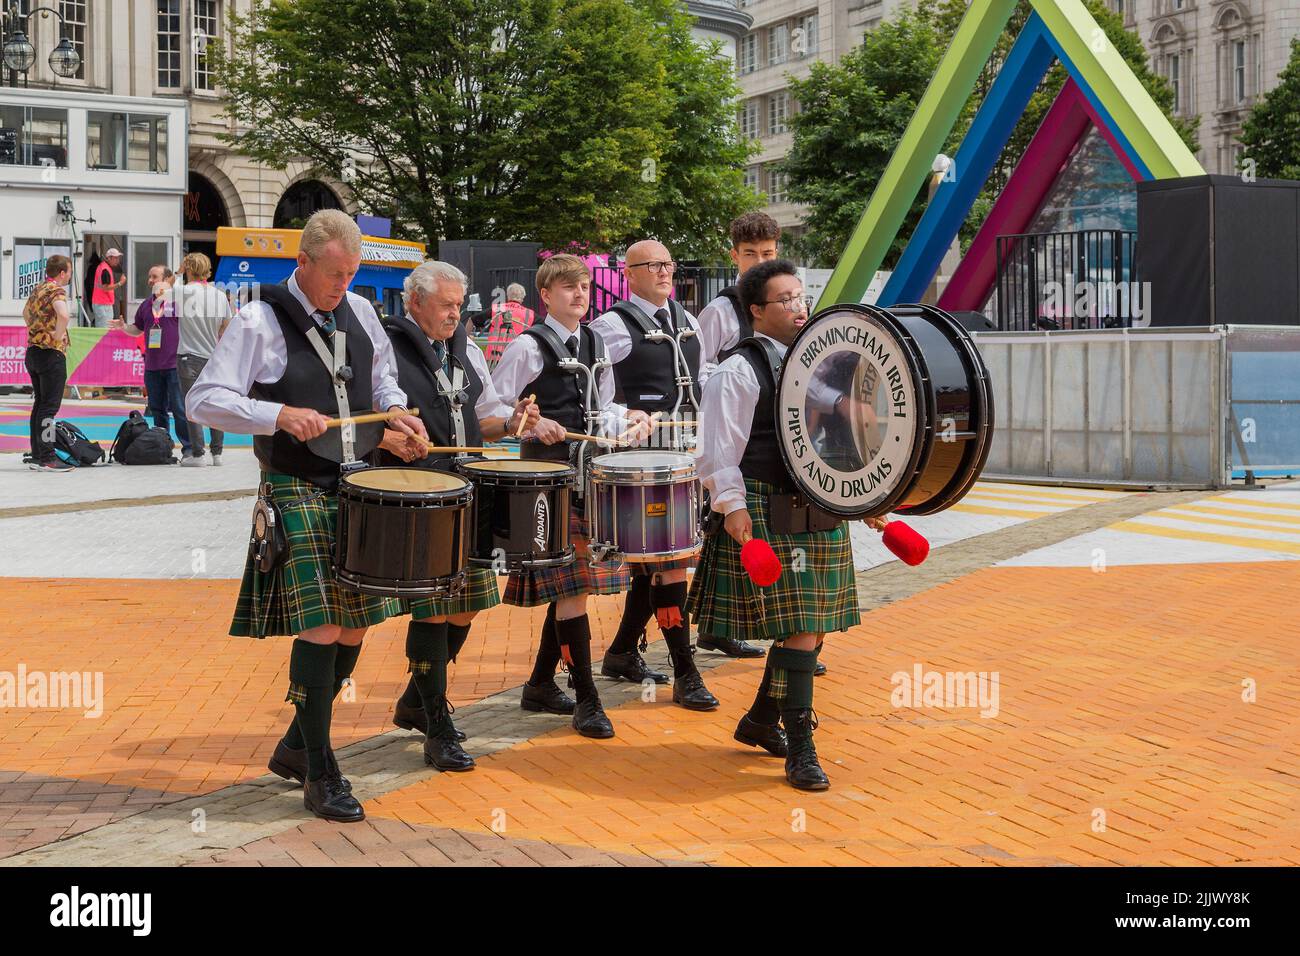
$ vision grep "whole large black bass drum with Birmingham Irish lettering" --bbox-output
[776,304,993,519]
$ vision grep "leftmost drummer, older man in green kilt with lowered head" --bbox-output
[185,209,428,822]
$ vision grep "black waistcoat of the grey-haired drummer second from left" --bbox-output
[374,319,484,471]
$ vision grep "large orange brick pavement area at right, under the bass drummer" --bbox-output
[367,563,1300,865]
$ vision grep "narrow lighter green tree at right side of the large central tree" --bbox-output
[627,0,762,263]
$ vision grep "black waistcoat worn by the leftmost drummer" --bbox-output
[248,284,374,490]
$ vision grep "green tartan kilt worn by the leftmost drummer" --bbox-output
[230,472,402,637]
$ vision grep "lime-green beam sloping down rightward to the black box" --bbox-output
[1030,0,1205,179]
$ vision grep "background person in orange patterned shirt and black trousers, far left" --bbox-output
[22,256,77,475]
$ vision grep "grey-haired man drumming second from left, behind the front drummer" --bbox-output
[376,261,540,770]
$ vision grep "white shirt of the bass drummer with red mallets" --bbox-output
[696,332,785,515]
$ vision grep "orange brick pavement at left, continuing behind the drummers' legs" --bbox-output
[0,579,621,795]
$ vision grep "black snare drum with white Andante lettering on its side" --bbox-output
[456,458,575,571]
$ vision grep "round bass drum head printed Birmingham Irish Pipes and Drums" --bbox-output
[776,304,933,518]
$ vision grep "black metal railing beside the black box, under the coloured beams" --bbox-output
[996,229,1149,332]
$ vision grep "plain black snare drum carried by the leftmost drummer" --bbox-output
[334,468,473,597]
